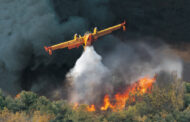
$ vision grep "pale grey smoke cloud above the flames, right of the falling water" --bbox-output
[105,39,183,83]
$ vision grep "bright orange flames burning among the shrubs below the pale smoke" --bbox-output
[87,77,156,111]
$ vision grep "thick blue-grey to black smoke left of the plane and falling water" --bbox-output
[0,0,87,94]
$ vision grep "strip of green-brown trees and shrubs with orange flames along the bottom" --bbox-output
[0,76,190,122]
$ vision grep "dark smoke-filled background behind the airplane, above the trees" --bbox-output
[0,0,190,95]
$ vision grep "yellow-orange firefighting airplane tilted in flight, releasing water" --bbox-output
[44,21,126,55]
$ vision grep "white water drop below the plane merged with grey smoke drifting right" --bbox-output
[67,42,182,104]
